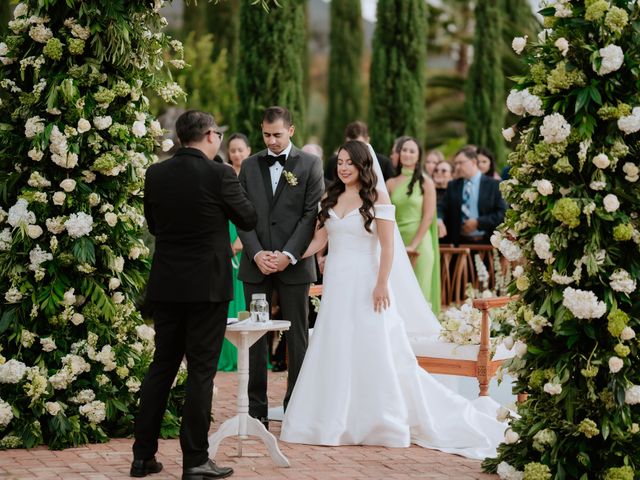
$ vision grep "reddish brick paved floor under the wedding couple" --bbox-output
[0,373,498,480]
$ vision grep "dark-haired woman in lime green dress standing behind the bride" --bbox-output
[387,137,440,315]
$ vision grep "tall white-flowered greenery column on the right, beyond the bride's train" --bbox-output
[484,0,640,480]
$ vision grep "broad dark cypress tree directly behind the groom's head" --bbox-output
[236,0,306,148]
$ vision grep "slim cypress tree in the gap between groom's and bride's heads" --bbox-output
[324,0,363,156]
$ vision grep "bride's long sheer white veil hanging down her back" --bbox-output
[367,144,442,335]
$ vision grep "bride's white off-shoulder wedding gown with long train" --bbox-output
[280,205,506,459]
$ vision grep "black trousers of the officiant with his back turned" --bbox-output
[133,302,229,468]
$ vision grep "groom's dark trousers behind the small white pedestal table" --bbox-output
[244,275,309,418]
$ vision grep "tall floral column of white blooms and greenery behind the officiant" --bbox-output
[0,0,182,448]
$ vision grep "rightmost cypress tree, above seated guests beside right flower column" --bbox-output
[465,0,505,164]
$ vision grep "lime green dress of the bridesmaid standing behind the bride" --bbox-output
[391,178,440,315]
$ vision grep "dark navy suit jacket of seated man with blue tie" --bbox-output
[438,175,507,245]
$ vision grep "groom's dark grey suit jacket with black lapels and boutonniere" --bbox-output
[238,147,324,284]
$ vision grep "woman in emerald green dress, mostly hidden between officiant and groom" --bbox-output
[218,133,251,372]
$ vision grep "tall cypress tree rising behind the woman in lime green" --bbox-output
[369,0,427,152]
